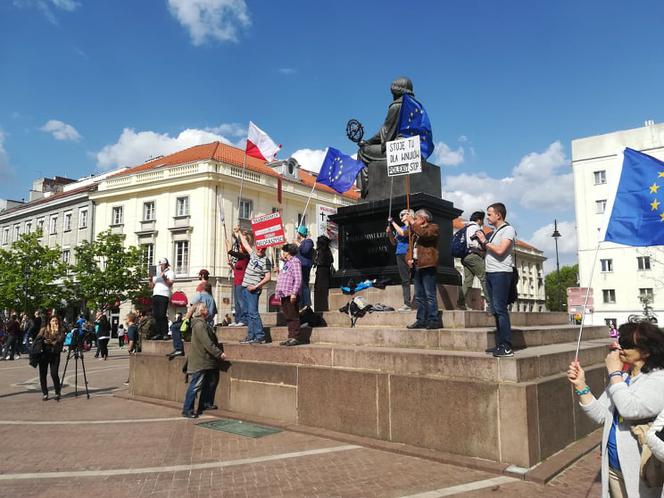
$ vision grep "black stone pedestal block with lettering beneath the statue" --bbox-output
[330,194,462,287]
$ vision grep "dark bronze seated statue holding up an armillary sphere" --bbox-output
[346,77,415,199]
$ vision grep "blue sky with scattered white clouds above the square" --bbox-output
[0,0,664,270]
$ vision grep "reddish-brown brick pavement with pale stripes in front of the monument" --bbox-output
[0,346,600,498]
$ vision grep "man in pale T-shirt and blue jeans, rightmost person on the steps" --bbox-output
[477,202,516,358]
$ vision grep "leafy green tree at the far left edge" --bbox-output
[0,232,69,313]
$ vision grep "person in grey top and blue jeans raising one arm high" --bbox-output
[235,227,272,344]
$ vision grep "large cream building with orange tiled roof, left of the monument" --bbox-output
[90,142,359,315]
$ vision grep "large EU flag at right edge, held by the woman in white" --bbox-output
[604,148,664,247]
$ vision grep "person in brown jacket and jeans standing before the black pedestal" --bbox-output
[404,209,442,329]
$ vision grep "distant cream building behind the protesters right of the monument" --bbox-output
[452,218,547,311]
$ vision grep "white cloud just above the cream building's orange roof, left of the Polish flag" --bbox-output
[96,125,241,169]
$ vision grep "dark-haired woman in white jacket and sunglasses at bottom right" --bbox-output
[567,323,664,498]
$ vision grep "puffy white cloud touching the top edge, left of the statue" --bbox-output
[168,0,251,46]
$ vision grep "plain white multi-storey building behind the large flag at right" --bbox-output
[570,121,664,325]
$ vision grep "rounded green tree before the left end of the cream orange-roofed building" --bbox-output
[73,230,147,311]
